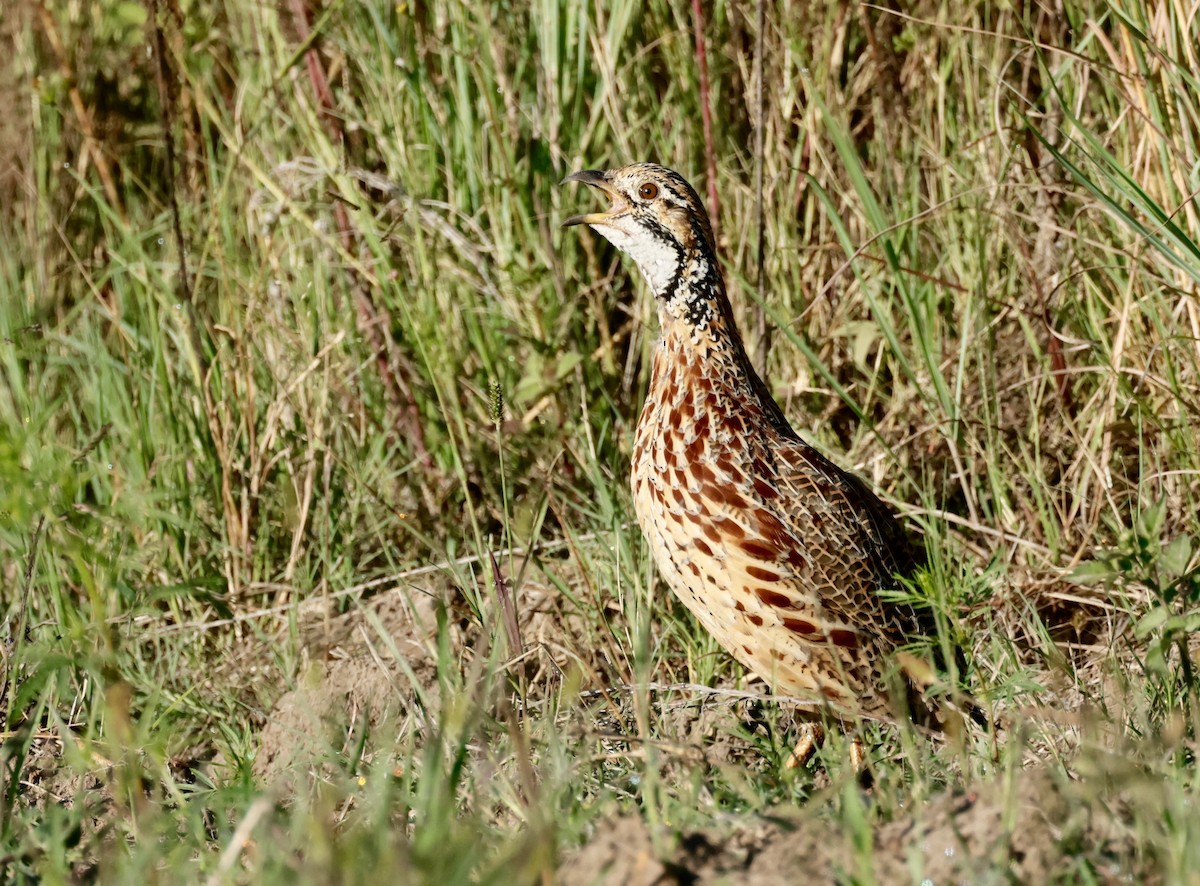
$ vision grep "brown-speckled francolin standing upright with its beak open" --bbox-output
[562,163,932,768]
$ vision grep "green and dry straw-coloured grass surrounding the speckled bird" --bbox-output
[0,0,1200,882]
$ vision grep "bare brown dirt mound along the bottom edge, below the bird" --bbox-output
[559,753,1161,886]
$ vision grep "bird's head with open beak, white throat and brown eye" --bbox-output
[563,163,720,301]
